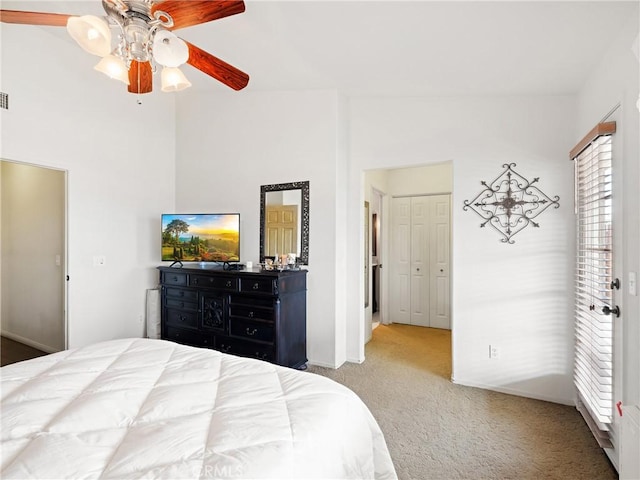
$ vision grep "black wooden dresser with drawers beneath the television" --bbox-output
[158,265,307,368]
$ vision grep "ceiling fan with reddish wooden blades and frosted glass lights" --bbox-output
[0,0,249,93]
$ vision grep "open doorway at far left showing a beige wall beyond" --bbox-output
[0,160,67,353]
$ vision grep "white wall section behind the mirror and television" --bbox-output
[176,91,345,366]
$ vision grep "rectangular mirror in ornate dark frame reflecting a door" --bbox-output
[260,181,309,265]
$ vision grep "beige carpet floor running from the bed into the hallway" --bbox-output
[308,324,618,480]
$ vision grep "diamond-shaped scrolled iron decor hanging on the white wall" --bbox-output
[462,163,560,243]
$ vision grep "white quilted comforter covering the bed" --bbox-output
[0,339,396,479]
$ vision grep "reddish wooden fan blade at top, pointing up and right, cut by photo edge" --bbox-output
[151,0,244,30]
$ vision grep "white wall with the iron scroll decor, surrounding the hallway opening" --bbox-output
[348,97,575,403]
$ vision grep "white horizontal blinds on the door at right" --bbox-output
[572,123,615,448]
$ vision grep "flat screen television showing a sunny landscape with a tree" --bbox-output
[162,213,240,262]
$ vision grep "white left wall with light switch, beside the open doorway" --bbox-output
[0,24,175,347]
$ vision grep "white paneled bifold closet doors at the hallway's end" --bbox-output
[389,195,451,329]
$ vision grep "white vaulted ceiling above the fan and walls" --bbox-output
[0,0,639,96]
